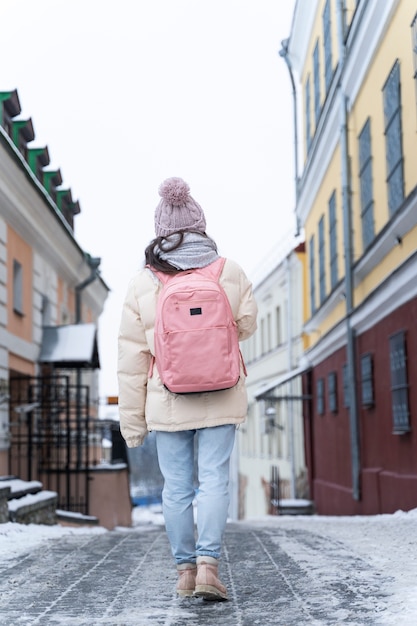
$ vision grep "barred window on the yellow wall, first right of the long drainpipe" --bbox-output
[359,118,375,250]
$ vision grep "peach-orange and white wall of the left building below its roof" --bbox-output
[0,94,108,460]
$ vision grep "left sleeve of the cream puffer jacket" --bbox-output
[117,278,151,448]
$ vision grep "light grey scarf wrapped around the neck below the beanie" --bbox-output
[154,232,219,270]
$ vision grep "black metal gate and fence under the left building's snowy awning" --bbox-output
[9,375,101,515]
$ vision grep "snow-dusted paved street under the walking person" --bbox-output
[0,511,417,626]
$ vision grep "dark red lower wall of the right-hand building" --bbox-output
[310,298,417,515]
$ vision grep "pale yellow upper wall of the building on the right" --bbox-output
[301,1,417,345]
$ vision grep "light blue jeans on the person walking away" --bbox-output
[156,424,236,565]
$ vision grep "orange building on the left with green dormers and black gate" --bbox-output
[0,90,130,527]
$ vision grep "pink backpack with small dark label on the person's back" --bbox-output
[150,258,243,393]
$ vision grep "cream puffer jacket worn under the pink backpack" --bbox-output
[118,259,258,448]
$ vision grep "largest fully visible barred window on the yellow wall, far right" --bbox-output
[383,61,404,216]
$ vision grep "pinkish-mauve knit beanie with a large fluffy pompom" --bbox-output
[155,177,206,237]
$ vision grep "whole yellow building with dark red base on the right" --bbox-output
[281,0,417,514]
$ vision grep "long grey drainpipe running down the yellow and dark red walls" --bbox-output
[336,0,361,500]
